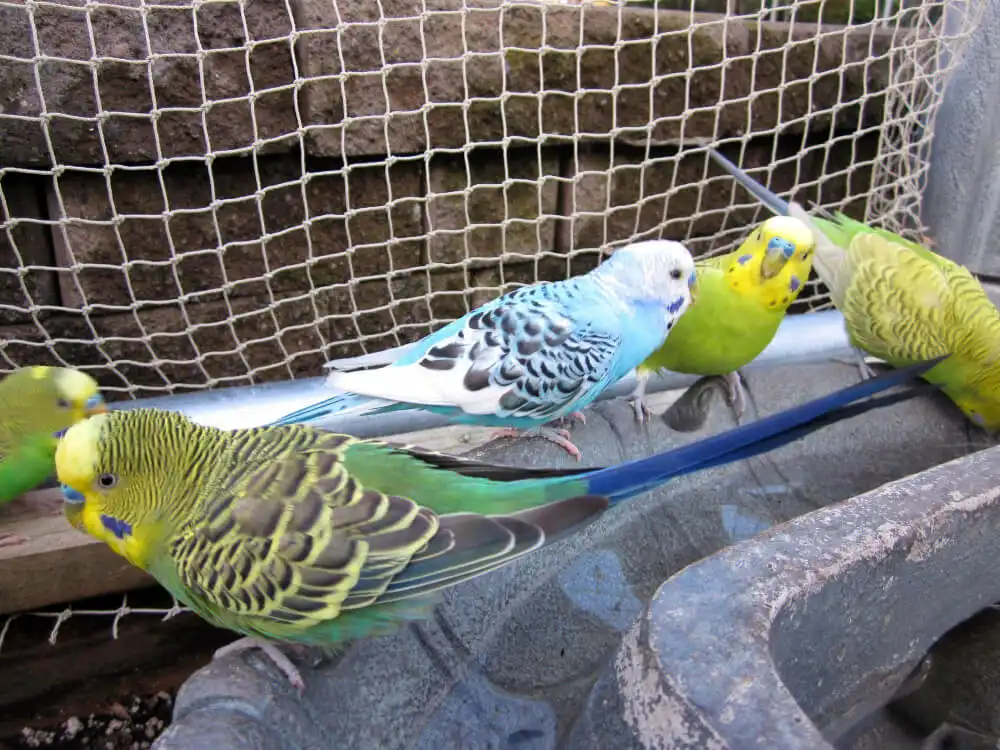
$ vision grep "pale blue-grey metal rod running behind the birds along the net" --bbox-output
[110,310,857,437]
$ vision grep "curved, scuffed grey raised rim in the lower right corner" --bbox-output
[571,428,1000,750]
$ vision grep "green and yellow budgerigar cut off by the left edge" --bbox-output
[0,367,105,546]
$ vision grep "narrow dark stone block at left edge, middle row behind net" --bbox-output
[0,172,59,323]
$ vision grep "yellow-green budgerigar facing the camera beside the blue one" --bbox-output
[632,216,815,420]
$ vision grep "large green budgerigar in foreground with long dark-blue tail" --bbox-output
[56,358,929,688]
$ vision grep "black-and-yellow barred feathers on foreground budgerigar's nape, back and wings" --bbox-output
[86,410,596,641]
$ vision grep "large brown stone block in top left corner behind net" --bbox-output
[0,0,298,164]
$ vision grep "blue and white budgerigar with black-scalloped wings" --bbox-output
[274,240,695,460]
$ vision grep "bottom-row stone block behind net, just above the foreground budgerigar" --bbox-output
[0,293,332,398]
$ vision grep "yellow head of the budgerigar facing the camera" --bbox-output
[725,216,816,312]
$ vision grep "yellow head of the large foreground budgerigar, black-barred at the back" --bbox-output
[56,409,211,568]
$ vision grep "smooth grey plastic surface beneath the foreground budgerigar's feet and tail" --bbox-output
[154,364,988,750]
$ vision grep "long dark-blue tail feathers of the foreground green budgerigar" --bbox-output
[587,357,945,503]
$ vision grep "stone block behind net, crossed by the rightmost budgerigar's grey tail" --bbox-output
[557,133,878,256]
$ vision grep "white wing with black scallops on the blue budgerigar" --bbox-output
[328,279,622,422]
